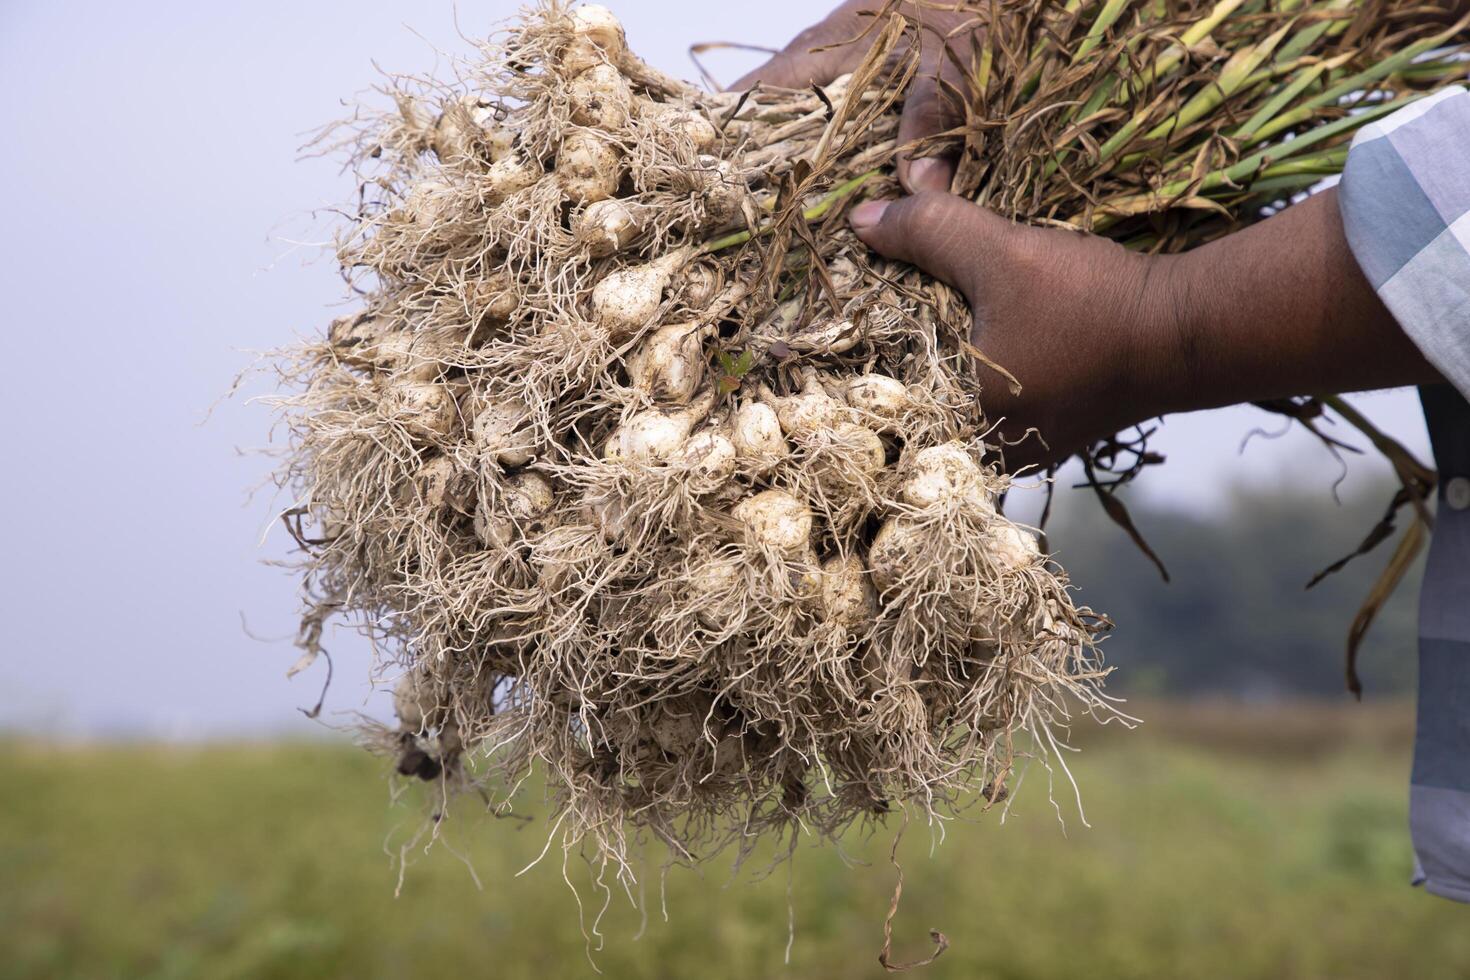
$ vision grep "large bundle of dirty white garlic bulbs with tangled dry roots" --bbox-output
[270,3,1103,874]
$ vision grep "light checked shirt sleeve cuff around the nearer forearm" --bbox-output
[1338,87,1470,394]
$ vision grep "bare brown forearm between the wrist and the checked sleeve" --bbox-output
[1138,191,1438,413]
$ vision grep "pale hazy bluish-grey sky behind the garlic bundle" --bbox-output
[0,0,1424,738]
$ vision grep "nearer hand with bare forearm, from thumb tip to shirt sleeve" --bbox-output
[850,190,1439,470]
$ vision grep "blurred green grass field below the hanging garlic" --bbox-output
[0,704,1470,980]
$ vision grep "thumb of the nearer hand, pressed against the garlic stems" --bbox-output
[848,191,1011,300]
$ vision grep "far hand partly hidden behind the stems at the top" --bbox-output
[731,0,980,192]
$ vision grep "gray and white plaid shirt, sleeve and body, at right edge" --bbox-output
[1338,88,1470,902]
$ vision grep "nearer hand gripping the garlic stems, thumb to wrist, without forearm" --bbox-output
[850,191,1177,470]
